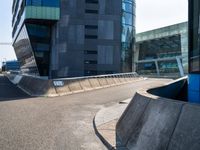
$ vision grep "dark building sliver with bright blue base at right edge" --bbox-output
[188,0,200,103]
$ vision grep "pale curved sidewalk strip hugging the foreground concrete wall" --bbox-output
[94,99,131,150]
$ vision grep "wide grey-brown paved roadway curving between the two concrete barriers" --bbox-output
[0,77,169,150]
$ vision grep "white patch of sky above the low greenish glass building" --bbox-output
[136,0,188,33]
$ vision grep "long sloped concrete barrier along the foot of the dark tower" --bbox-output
[6,73,144,97]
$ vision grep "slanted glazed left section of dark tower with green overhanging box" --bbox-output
[12,0,60,76]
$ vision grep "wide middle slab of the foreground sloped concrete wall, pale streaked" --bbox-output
[127,98,183,150]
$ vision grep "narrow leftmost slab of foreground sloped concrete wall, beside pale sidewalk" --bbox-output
[116,93,150,145]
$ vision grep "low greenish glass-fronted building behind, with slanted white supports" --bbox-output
[133,22,188,76]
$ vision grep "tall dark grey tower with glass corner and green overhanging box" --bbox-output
[12,0,135,78]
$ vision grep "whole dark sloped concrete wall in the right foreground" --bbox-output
[116,79,200,150]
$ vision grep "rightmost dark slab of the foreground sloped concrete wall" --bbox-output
[168,104,200,150]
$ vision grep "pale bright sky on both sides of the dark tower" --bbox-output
[0,0,188,66]
